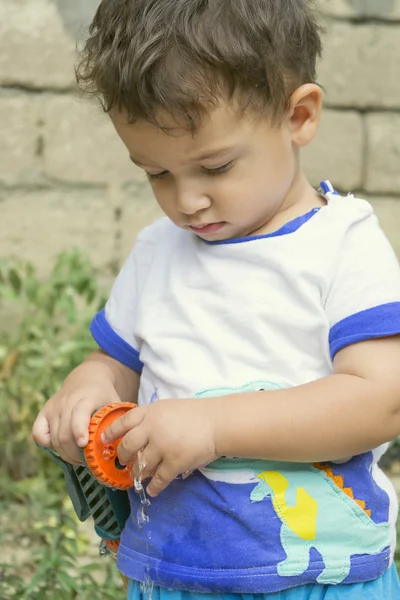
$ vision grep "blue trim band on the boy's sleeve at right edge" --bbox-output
[329,302,400,360]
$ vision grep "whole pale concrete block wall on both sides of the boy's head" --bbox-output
[0,0,400,274]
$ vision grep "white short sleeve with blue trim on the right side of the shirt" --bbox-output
[325,203,400,359]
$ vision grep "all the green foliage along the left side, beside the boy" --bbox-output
[0,251,123,600]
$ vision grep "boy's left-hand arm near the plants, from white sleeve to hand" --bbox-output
[32,234,152,464]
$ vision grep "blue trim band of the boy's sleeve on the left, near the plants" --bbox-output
[90,308,143,374]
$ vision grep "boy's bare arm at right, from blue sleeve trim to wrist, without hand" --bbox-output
[215,336,400,462]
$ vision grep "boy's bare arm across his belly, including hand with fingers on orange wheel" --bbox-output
[104,336,400,496]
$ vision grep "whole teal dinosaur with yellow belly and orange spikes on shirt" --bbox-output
[250,462,392,584]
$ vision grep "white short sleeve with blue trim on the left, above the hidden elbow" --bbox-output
[90,224,163,373]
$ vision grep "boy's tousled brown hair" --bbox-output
[76,0,322,129]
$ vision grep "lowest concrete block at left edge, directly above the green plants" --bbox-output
[0,189,116,275]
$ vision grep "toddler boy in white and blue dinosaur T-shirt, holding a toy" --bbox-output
[33,0,400,600]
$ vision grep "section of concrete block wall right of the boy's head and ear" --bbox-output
[303,0,400,257]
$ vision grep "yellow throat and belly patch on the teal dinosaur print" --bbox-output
[258,471,318,541]
